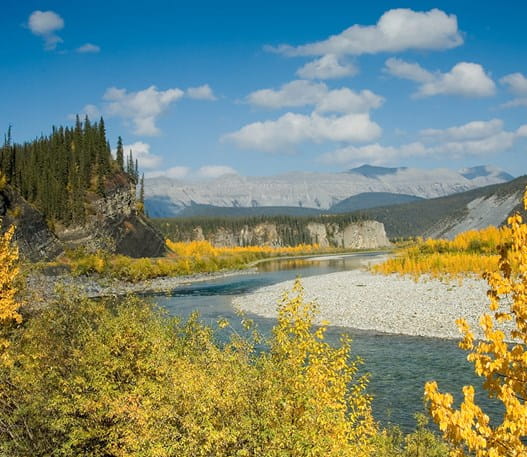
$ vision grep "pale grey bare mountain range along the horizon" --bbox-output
[145,165,513,217]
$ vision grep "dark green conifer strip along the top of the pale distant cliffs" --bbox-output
[152,214,364,246]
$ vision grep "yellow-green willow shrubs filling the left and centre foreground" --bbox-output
[0,283,377,457]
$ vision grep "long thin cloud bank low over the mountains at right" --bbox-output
[319,119,527,165]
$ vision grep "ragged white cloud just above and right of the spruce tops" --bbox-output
[103,86,184,135]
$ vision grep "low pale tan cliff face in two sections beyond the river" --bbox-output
[179,221,390,249]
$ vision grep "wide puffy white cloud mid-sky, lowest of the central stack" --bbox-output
[222,113,382,152]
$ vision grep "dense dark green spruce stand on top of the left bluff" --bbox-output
[0,116,143,225]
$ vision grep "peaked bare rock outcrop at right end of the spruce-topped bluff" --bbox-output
[57,177,166,257]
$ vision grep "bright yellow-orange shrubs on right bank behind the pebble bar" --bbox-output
[373,227,511,277]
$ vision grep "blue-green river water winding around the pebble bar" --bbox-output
[147,253,498,431]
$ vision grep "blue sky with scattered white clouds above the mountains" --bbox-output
[0,0,527,179]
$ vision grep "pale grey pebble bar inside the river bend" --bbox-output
[233,270,506,338]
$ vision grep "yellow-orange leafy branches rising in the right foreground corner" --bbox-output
[425,192,527,457]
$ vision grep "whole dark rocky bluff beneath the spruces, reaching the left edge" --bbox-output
[0,176,166,261]
